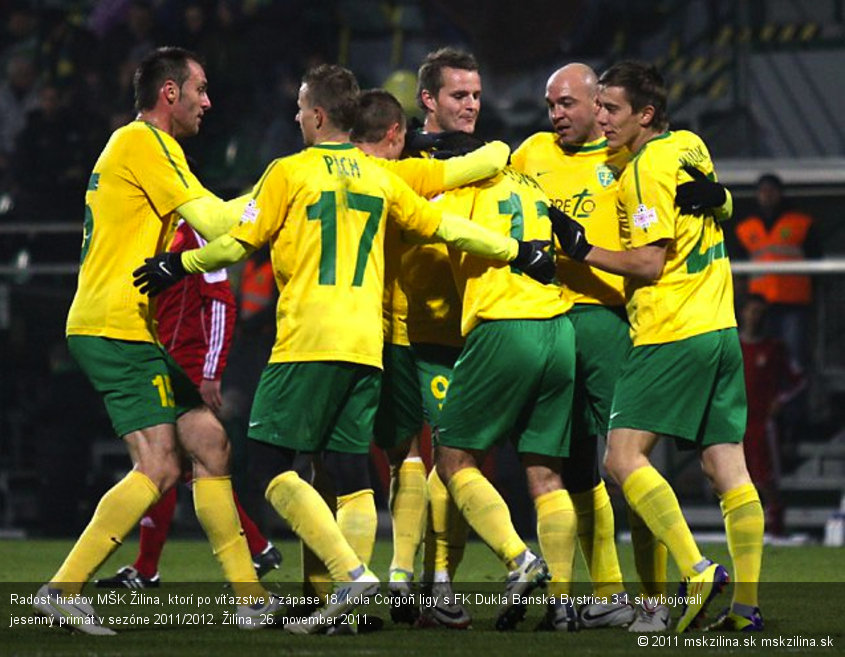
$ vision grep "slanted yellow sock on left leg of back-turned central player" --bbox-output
[449,468,528,570]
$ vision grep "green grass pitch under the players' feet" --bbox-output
[0,540,845,657]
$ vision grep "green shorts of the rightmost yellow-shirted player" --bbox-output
[610,328,747,449]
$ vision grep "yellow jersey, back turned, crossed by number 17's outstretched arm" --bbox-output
[442,167,572,336]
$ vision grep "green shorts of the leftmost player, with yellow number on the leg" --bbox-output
[67,335,203,436]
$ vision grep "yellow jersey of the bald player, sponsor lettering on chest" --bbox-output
[511,132,630,306]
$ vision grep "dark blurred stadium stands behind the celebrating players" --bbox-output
[0,0,845,540]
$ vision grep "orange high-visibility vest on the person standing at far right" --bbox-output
[736,212,813,305]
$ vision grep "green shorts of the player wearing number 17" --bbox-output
[248,361,381,454]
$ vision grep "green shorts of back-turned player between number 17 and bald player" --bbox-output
[437,315,575,457]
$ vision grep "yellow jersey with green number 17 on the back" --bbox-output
[229,143,441,368]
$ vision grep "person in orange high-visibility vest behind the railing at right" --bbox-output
[736,173,822,367]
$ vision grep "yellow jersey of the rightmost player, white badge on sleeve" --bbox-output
[617,130,736,346]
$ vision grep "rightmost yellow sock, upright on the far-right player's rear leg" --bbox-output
[721,484,764,607]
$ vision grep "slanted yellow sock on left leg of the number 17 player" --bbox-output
[264,471,361,582]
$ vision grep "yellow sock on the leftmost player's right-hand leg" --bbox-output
[193,477,266,598]
